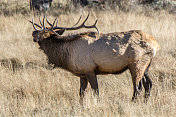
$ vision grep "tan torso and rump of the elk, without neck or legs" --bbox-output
[52,31,160,76]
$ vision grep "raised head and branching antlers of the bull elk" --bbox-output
[29,14,99,42]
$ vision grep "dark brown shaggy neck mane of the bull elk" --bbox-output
[38,35,70,70]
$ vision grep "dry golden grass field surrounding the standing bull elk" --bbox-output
[0,0,176,117]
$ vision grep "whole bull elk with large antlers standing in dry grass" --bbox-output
[30,15,160,100]
